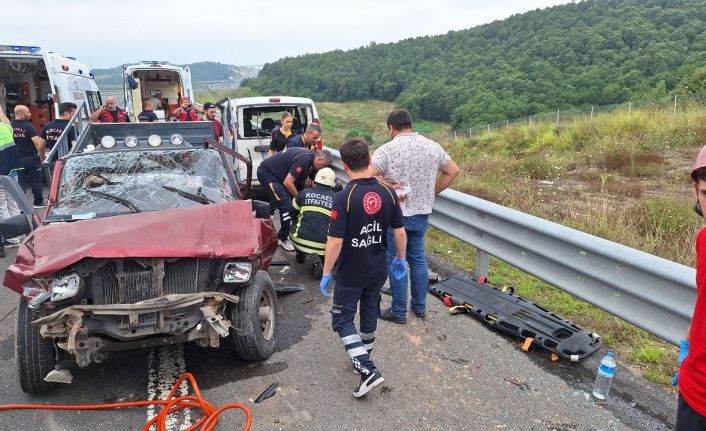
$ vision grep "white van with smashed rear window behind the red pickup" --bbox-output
[218,96,321,197]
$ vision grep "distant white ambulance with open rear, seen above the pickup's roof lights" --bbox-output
[123,61,196,121]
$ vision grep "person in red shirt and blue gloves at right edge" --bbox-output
[675,147,706,431]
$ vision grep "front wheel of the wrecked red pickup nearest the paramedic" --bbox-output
[230,271,279,361]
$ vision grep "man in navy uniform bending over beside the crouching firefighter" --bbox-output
[257,148,331,251]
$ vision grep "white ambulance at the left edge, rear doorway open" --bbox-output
[0,45,101,132]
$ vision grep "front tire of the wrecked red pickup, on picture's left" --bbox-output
[15,297,56,394]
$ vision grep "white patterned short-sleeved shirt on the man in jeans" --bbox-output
[371,133,451,217]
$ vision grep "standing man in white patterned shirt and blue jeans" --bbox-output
[369,110,459,323]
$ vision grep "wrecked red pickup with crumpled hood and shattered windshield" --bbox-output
[2,122,278,393]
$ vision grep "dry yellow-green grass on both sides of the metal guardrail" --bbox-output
[318,101,706,385]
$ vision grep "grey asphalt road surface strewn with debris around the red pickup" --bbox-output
[0,249,676,431]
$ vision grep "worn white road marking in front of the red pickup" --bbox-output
[147,344,192,431]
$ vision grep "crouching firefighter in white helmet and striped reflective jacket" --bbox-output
[289,168,336,268]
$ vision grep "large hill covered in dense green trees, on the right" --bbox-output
[244,0,706,128]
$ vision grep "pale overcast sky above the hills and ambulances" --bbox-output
[0,0,569,68]
